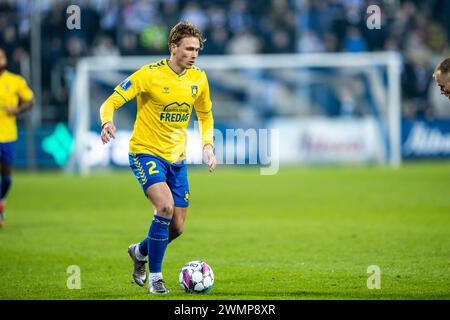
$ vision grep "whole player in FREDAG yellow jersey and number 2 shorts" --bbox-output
[100,22,216,293]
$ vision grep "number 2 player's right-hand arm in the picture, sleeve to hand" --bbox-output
[195,74,216,172]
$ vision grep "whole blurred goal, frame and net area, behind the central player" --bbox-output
[67,52,401,174]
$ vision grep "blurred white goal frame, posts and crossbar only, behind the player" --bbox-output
[66,52,402,174]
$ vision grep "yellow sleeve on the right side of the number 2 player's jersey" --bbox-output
[194,74,214,145]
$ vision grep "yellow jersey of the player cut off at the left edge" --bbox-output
[0,70,33,143]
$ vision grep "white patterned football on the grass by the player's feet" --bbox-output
[179,260,214,293]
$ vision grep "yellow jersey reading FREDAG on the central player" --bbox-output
[100,59,213,163]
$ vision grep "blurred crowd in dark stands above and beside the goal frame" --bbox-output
[0,0,450,124]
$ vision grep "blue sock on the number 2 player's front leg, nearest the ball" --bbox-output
[148,215,172,273]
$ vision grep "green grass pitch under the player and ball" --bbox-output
[0,163,450,299]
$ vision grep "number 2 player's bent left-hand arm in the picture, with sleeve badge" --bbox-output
[100,66,148,144]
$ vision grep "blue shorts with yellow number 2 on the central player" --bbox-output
[128,153,189,207]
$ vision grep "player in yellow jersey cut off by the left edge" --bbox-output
[0,48,33,227]
